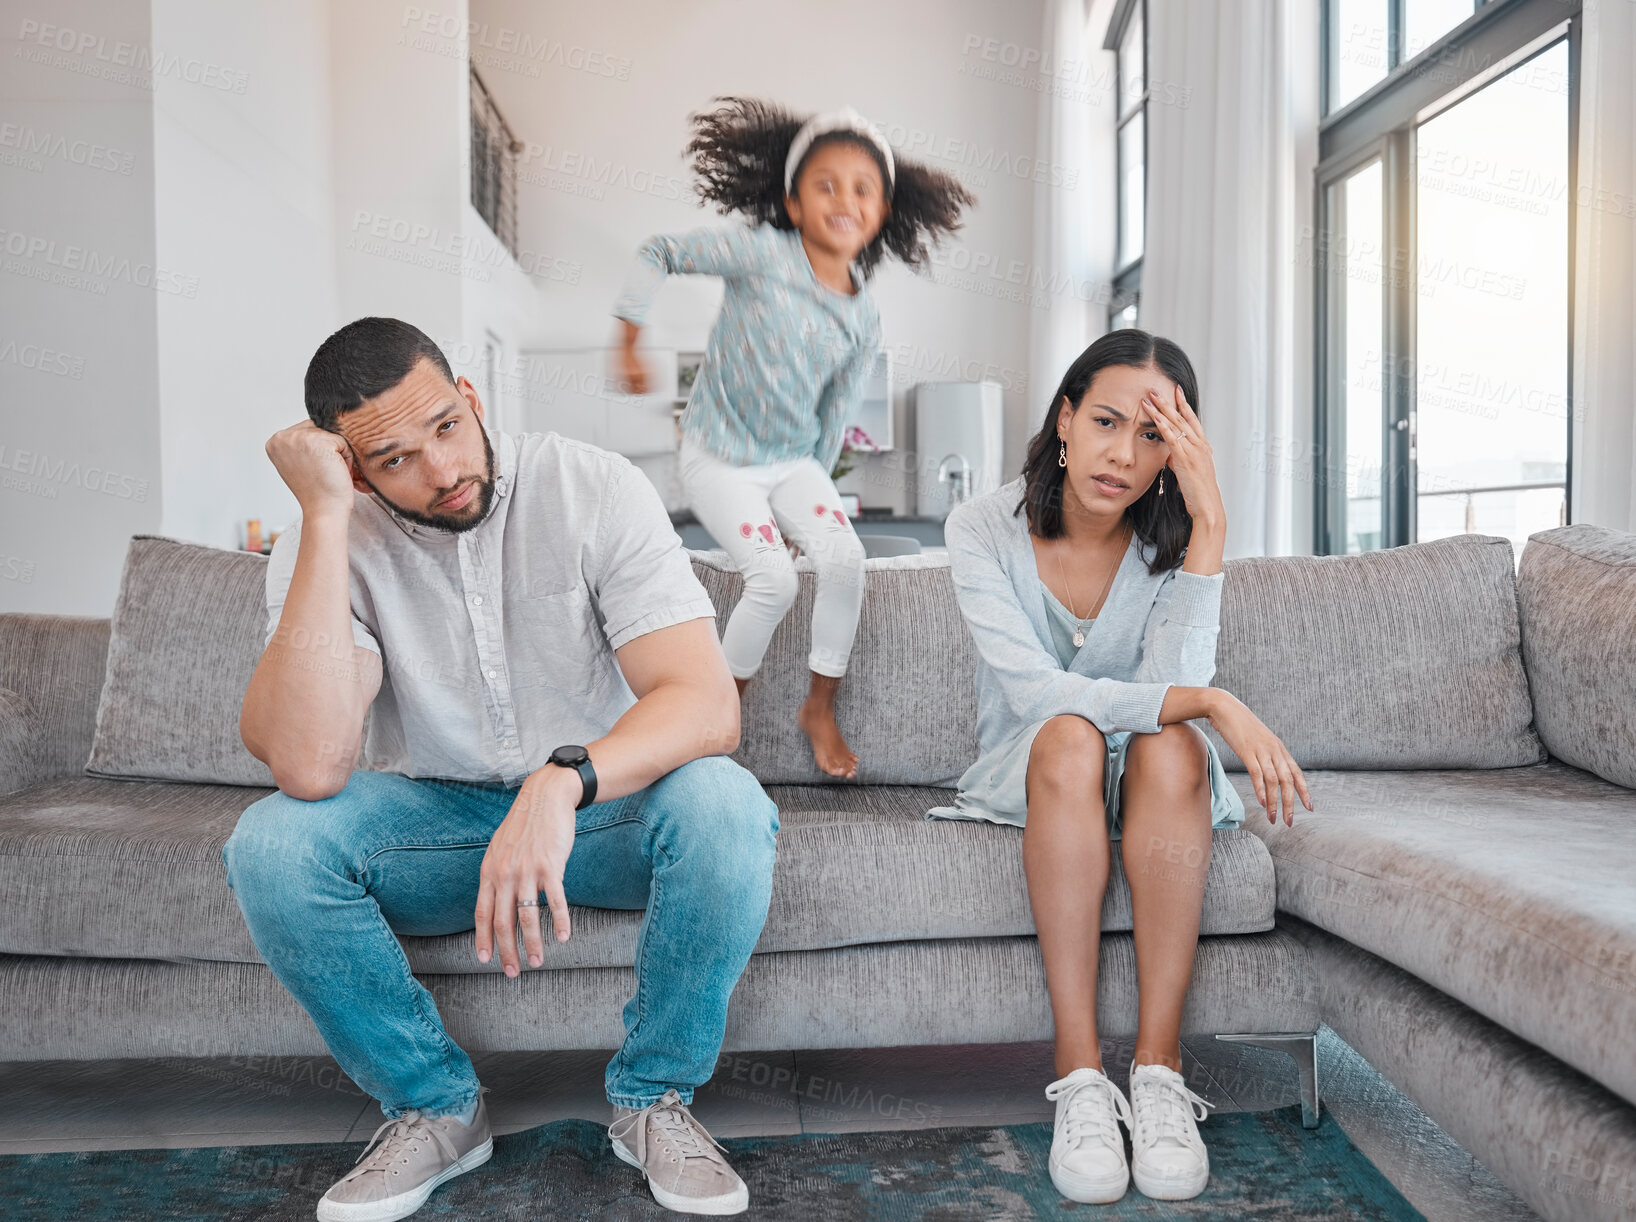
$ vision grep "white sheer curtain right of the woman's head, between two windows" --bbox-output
[1140,0,1317,556]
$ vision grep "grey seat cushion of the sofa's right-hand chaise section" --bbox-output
[1234,761,1636,1103]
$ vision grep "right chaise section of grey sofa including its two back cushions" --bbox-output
[1216,525,1636,1222]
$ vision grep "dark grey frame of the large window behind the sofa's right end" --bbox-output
[1312,0,1582,556]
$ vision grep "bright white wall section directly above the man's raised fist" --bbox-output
[154,0,337,548]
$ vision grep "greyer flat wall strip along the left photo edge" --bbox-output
[0,0,163,615]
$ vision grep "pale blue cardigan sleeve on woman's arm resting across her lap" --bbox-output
[944,502,1171,735]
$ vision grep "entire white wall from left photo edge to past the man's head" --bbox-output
[0,0,561,615]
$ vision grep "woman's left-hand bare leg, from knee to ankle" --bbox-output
[1023,713,1111,1078]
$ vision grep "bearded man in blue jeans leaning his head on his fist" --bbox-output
[222,317,779,1222]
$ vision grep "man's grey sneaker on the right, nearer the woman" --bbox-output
[609,1089,749,1214]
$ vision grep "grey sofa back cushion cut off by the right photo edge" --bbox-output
[1517,525,1636,788]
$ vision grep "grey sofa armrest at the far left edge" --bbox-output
[0,613,108,795]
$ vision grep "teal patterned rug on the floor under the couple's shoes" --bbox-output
[9,1107,1425,1222]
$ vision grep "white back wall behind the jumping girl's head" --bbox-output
[470,0,1050,510]
